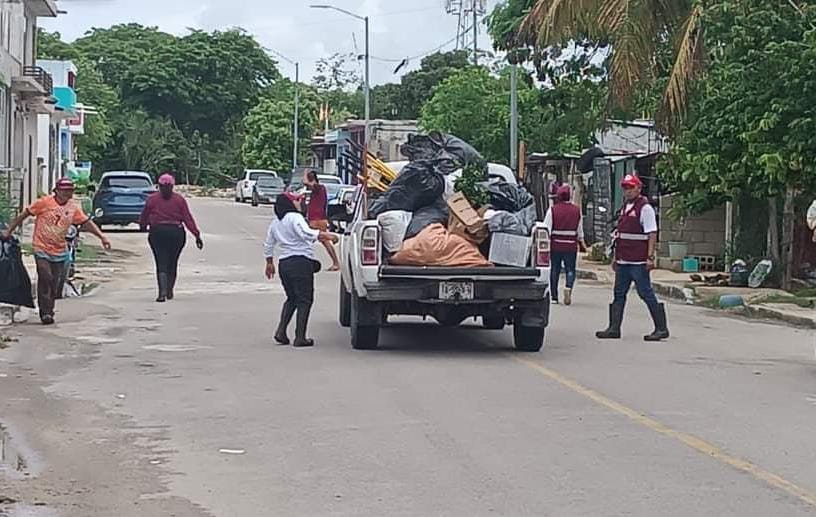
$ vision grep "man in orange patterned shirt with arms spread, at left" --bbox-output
[0,178,111,325]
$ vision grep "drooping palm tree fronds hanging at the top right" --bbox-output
[519,0,705,134]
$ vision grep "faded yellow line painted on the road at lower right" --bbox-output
[512,356,816,507]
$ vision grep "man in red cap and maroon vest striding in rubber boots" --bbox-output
[595,174,669,341]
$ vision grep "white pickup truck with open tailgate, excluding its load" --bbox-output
[339,166,550,352]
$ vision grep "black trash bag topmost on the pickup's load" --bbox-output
[402,131,484,174]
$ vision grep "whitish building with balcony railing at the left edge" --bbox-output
[0,0,57,212]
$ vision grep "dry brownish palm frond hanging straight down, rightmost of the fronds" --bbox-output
[657,4,705,134]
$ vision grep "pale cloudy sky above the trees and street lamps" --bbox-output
[44,0,500,84]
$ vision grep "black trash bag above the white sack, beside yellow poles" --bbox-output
[368,160,445,217]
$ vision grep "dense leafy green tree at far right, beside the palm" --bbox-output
[665,0,816,286]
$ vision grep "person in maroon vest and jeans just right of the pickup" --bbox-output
[544,185,586,305]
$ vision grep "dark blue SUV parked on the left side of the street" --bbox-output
[93,171,156,226]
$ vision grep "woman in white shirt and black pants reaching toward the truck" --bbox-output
[264,192,337,347]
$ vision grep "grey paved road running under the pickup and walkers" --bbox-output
[0,201,816,517]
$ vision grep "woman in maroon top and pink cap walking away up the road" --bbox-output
[139,173,204,303]
